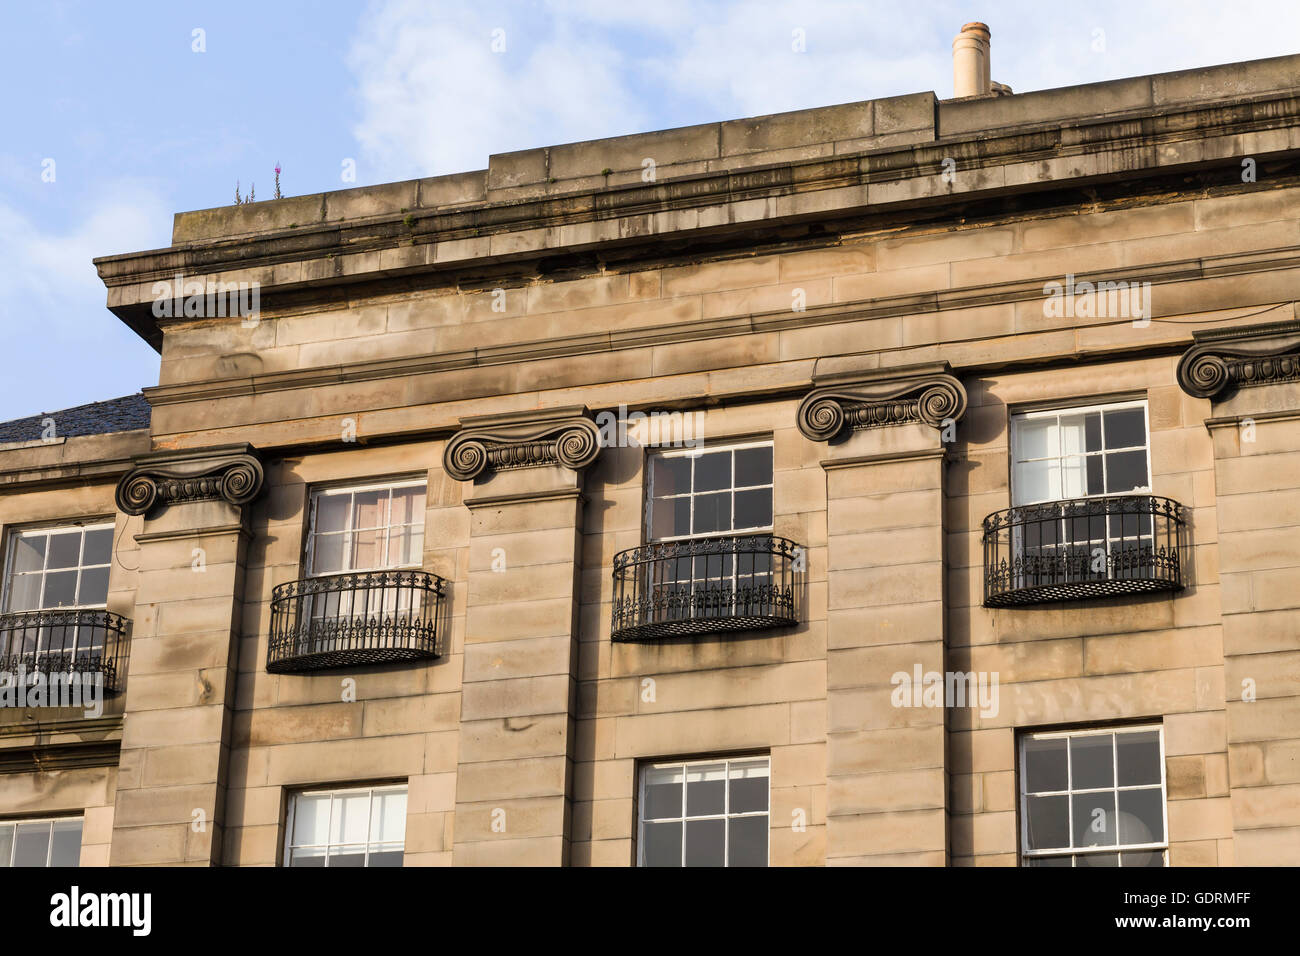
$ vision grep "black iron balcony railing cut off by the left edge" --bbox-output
[0,607,129,692]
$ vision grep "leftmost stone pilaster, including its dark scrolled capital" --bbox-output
[111,445,263,866]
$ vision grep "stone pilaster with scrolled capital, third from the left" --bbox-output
[798,363,966,865]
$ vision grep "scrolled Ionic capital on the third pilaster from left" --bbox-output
[797,373,966,441]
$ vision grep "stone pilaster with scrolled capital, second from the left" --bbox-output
[443,407,599,866]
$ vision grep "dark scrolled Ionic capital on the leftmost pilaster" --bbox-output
[116,445,264,515]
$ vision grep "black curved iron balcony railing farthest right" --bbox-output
[984,494,1190,607]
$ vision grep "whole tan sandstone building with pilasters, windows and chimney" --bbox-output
[0,25,1300,866]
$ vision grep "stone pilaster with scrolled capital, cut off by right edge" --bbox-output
[1178,321,1300,865]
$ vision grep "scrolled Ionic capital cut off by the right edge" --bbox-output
[1178,320,1300,398]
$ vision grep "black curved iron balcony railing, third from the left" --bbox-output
[611,535,806,641]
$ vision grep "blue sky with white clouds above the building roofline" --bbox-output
[0,0,1300,420]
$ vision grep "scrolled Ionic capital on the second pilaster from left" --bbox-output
[442,406,601,481]
